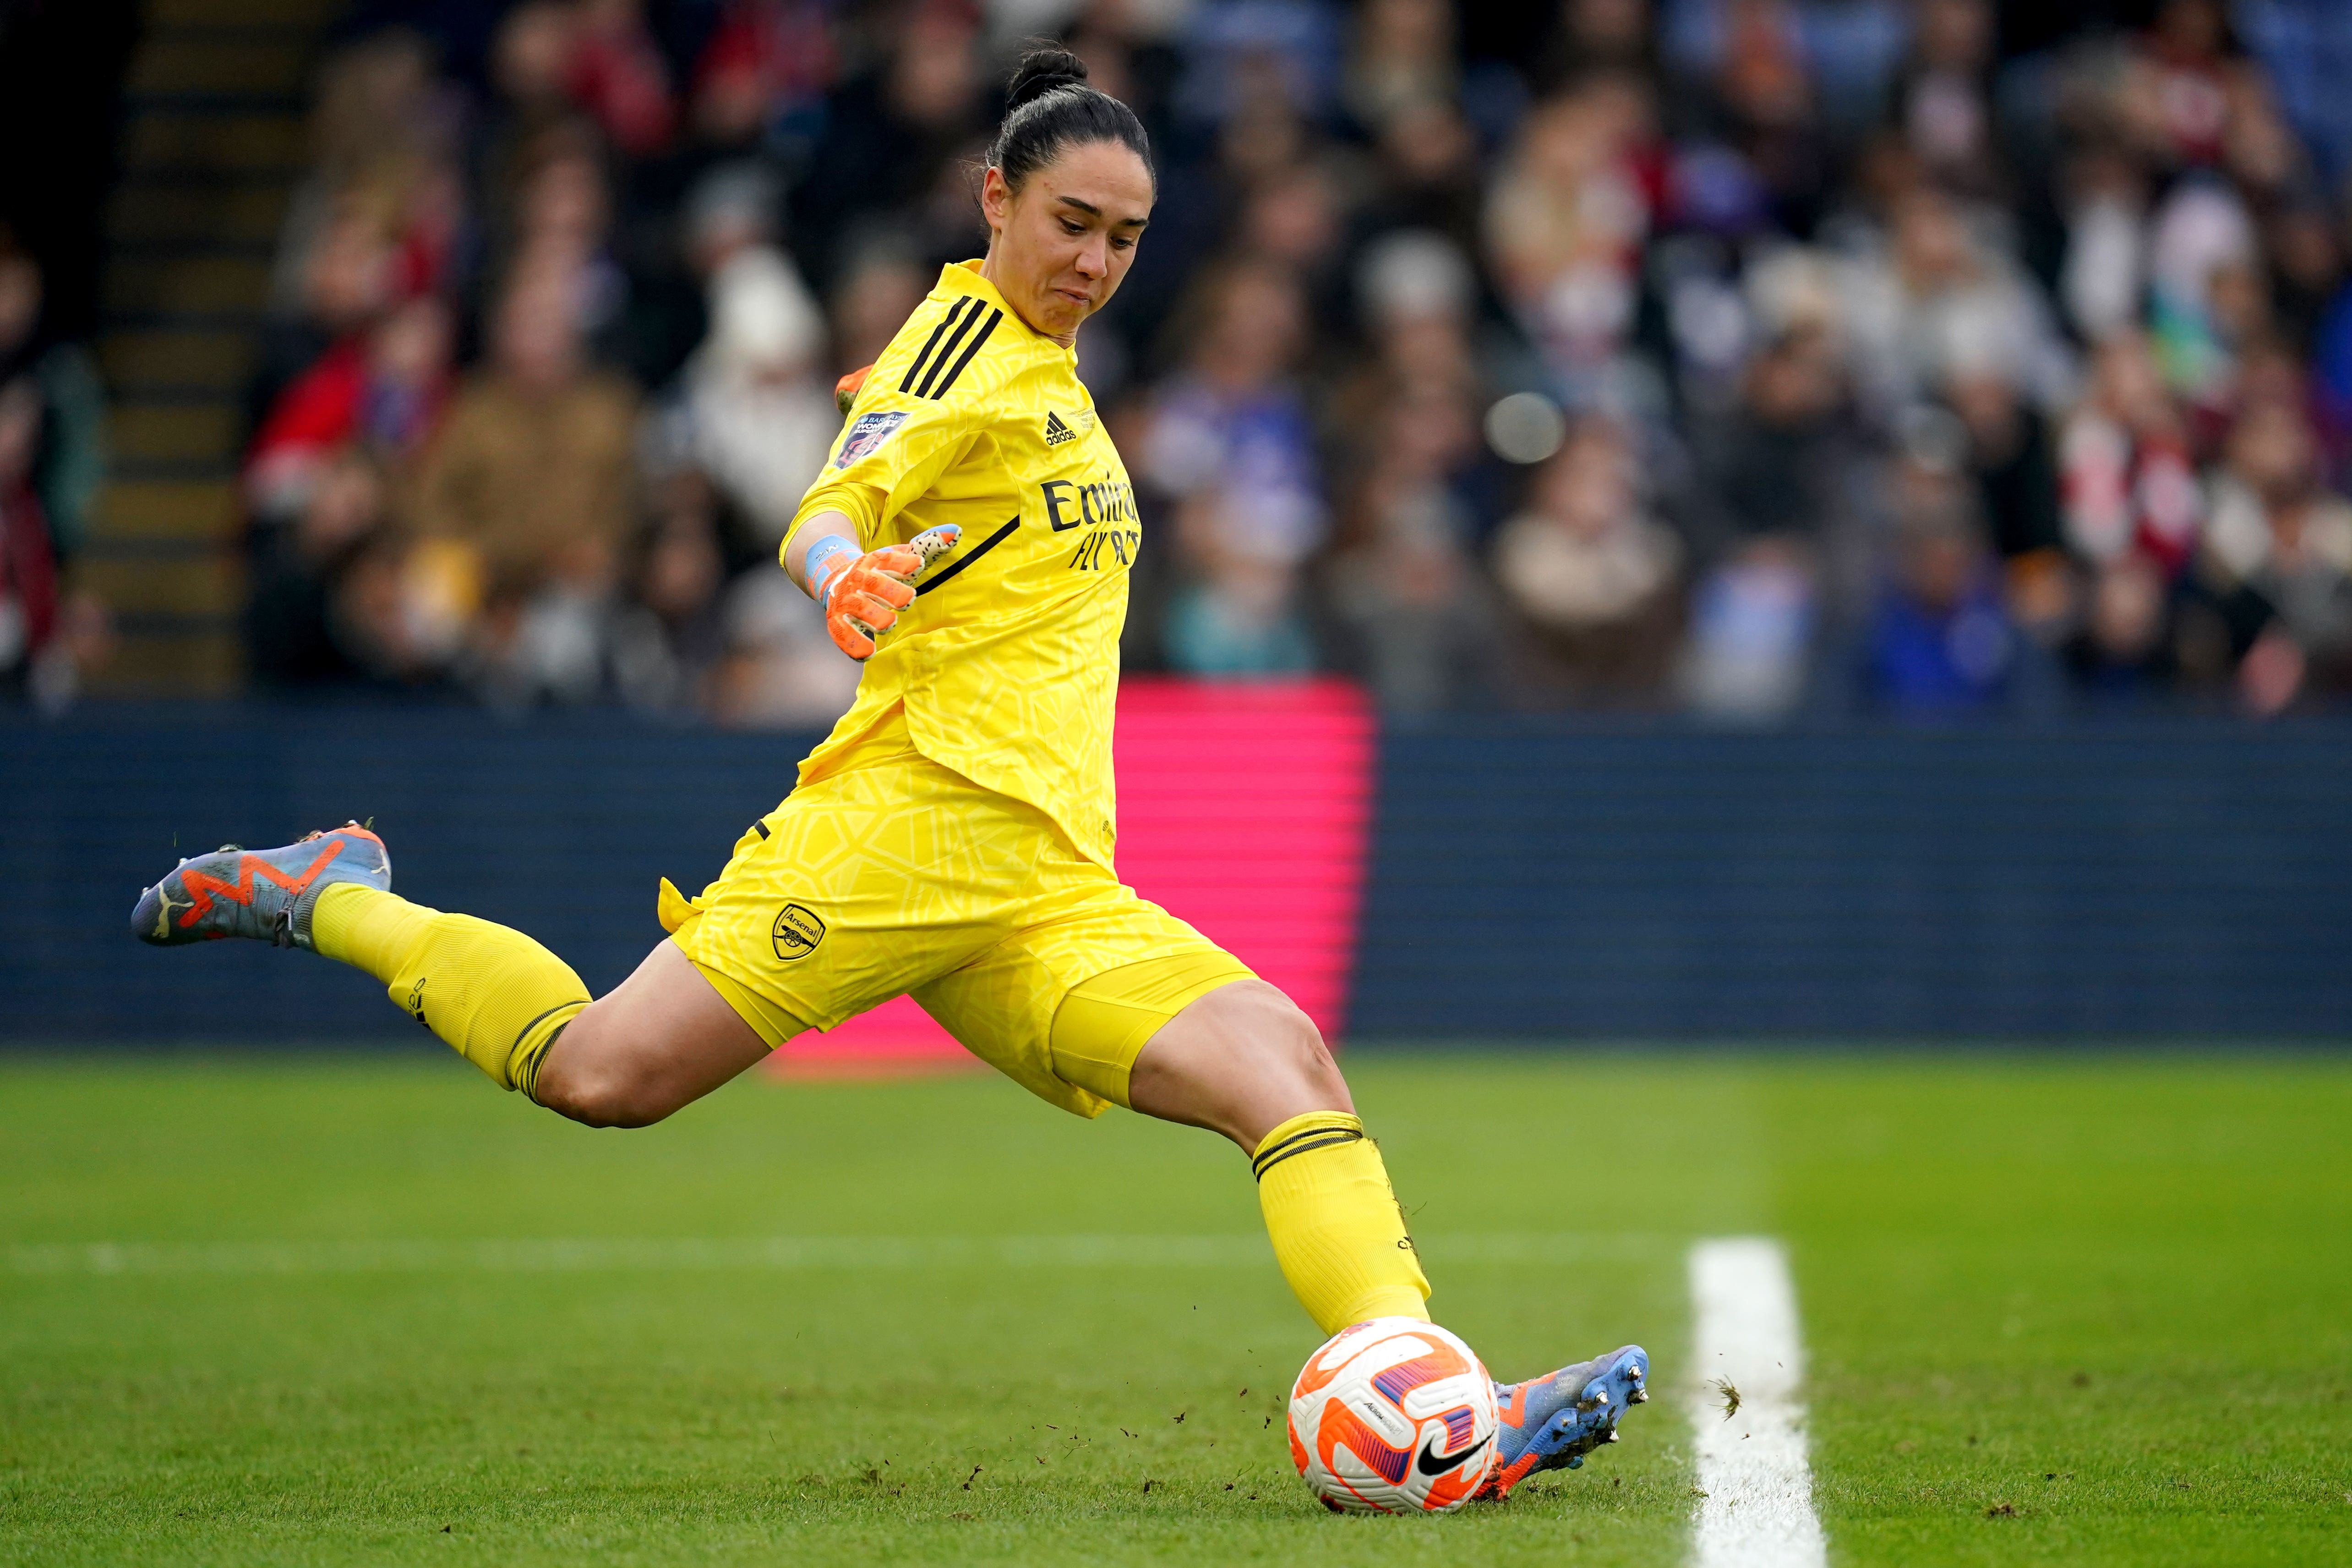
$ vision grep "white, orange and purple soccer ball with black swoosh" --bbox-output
[1291,1317,1496,1514]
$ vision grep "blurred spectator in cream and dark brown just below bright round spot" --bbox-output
[1494,421,1684,708]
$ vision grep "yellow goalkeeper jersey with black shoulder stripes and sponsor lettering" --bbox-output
[795,261,1143,868]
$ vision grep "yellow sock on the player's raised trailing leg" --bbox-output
[311,881,588,1093]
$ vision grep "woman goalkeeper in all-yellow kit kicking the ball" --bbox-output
[134,47,1647,1493]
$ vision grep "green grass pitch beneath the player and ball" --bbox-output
[0,1053,2352,1566]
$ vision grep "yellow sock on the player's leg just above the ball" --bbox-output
[1249,1109,1430,1333]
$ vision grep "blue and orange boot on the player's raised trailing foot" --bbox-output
[132,823,393,950]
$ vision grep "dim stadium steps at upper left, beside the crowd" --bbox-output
[75,0,341,698]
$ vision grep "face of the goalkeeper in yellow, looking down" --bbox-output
[981,141,1152,343]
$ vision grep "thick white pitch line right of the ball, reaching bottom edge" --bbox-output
[1691,1236,1828,1568]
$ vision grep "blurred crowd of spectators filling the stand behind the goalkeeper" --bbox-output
[55,0,2352,727]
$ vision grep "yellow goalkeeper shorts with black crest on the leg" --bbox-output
[661,719,1254,1117]
